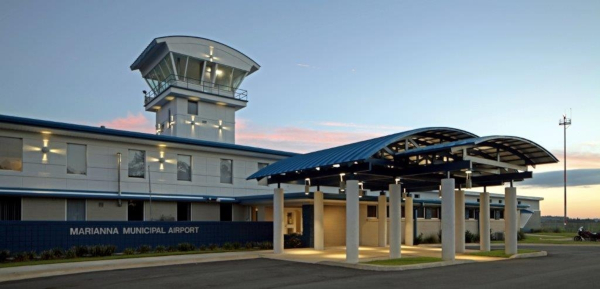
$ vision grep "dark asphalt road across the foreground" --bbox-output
[0,246,600,289]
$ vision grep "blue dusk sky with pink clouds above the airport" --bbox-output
[0,0,600,218]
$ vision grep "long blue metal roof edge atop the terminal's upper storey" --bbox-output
[0,115,297,157]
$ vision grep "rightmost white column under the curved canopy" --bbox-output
[504,187,518,255]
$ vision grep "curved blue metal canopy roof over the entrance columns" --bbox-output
[248,127,558,190]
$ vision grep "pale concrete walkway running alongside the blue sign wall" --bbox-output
[0,251,272,282]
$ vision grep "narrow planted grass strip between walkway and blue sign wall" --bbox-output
[0,249,258,268]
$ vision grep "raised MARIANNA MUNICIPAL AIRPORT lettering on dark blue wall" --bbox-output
[69,226,200,236]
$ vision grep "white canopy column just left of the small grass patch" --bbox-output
[346,180,359,264]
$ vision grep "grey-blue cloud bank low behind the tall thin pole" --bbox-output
[521,169,600,188]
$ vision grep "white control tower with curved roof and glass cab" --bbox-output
[130,36,260,143]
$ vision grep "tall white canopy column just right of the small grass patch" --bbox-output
[441,178,456,261]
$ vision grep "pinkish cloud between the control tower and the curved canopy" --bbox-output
[236,119,385,153]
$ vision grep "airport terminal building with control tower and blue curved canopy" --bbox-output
[0,36,557,254]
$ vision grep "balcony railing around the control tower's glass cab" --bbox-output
[144,74,248,104]
